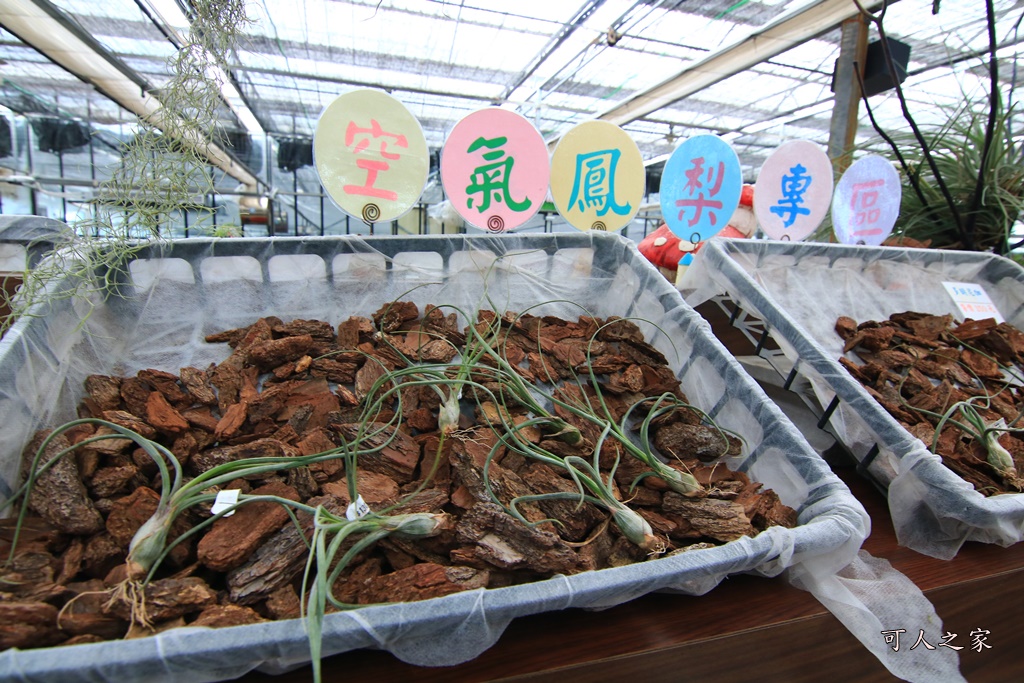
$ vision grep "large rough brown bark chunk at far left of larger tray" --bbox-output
[24,431,103,536]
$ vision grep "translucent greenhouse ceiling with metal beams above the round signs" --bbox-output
[0,0,1024,185]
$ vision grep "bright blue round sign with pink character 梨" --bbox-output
[659,135,743,244]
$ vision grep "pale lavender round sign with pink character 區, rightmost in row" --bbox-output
[831,155,903,247]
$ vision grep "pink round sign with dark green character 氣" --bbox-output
[441,108,551,232]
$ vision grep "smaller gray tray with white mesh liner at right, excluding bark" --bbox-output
[680,239,1024,559]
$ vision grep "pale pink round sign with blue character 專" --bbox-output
[754,140,833,242]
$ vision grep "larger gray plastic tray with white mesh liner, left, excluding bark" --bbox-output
[0,232,963,683]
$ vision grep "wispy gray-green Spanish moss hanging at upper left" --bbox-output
[2,0,248,328]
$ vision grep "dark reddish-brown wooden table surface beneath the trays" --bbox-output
[243,469,1024,683]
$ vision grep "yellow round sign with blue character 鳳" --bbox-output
[551,121,646,230]
